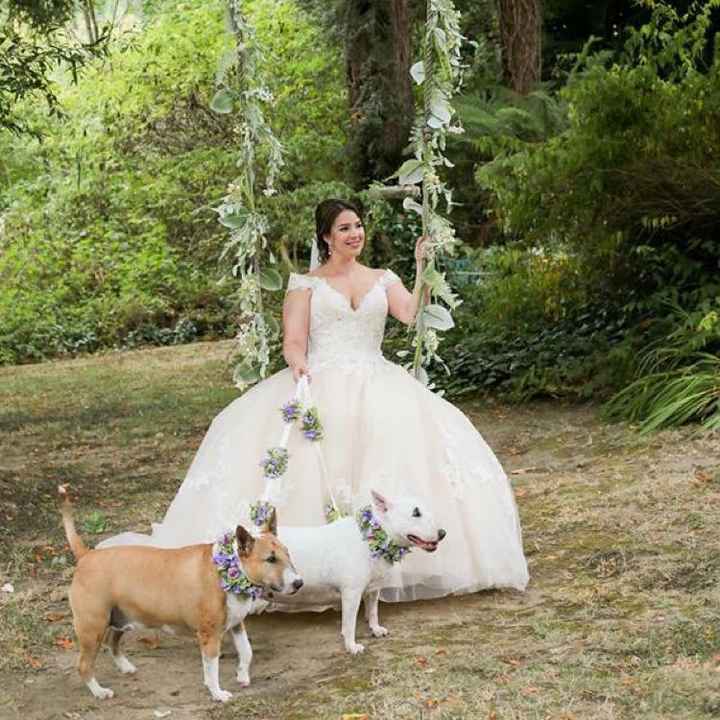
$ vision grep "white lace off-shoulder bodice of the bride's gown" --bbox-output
[288,270,400,371]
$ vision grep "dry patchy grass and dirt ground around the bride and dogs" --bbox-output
[0,344,720,720]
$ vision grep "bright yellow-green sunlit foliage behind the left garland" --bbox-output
[0,0,344,363]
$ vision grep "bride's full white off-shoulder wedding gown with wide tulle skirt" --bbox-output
[101,270,528,601]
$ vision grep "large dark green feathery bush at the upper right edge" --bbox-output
[478,2,720,295]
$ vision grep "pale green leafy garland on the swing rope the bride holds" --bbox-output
[395,0,464,382]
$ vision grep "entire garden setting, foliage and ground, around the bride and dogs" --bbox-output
[0,0,720,720]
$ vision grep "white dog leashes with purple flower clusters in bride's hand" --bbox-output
[250,375,343,527]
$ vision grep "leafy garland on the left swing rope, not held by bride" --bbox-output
[210,0,283,390]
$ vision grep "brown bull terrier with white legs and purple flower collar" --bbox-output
[58,486,303,702]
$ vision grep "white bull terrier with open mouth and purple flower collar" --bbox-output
[275,491,446,655]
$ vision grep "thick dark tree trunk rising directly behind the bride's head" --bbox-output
[344,0,414,185]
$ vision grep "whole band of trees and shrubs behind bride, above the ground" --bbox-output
[0,0,720,427]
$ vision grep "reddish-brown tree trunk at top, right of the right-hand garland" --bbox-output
[498,0,542,95]
